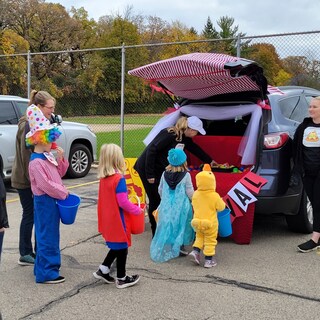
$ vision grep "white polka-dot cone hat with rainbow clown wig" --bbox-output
[26,104,61,146]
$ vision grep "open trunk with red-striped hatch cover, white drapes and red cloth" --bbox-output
[129,53,271,244]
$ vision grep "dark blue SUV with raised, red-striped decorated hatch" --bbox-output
[129,53,320,233]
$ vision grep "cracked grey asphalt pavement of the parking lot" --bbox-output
[0,169,320,320]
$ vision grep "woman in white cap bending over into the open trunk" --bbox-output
[134,116,215,235]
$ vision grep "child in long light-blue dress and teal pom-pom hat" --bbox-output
[150,148,194,262]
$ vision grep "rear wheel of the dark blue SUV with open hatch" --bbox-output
[286,191,313,234]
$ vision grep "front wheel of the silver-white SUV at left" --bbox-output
[67,144,92,178]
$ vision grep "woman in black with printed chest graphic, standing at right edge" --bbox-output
[293,96,320,252]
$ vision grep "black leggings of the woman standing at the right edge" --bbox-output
[303,174,320,232]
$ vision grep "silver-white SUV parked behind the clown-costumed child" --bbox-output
[0,95,97,180]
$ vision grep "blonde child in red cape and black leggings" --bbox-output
[93,144,144,289]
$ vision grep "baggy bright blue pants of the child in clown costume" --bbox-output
[34,195,61,283]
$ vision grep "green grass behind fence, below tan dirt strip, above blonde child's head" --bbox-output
[97,128,151,158]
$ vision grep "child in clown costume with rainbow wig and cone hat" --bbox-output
[26,105,69,284]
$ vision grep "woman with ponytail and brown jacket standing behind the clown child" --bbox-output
[11,90,56,266]
